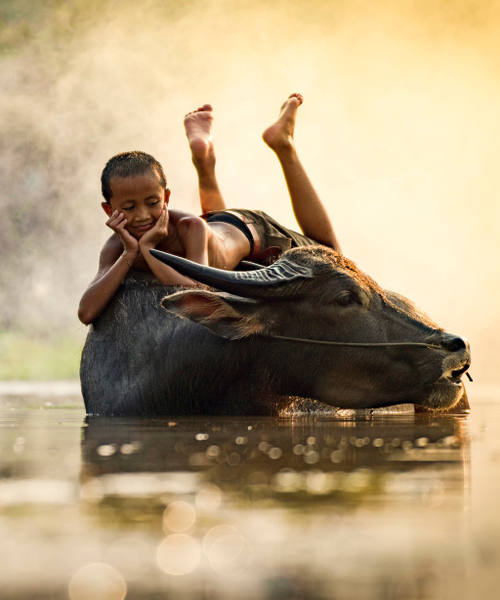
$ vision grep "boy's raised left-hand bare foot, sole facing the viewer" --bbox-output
[184,104,215,170]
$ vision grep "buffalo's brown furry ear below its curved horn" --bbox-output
[161,290,264,340]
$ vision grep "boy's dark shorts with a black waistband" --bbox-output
[202,208,319,264]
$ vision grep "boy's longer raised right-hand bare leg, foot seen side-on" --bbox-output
[262,94,340,252]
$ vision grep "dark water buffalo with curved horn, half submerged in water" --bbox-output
[80,246,470,415]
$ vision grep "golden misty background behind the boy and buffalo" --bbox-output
[0,0,500,382]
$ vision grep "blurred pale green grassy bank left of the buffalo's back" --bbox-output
[0,332,83,380]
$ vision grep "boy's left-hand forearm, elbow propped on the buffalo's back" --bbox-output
[78,235,137,325]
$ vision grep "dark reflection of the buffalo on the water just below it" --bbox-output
[81,415,467,508]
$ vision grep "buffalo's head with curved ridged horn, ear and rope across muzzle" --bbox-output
[152,246,470,410]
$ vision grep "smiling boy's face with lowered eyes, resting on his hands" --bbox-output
[101,171,170,239]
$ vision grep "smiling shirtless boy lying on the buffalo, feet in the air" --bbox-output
[78,94,340,325]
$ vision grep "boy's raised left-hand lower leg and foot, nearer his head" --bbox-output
[184,104,226,213]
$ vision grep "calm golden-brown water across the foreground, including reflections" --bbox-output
[0,384,500,600]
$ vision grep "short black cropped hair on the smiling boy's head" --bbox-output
[101,150,167,202]
